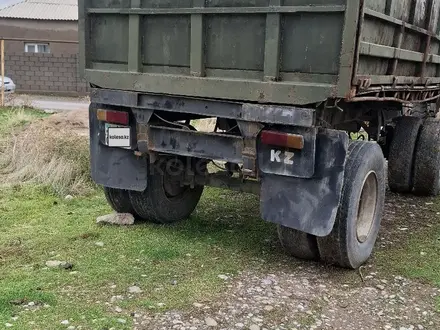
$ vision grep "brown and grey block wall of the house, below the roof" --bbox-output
[0,19,87,95]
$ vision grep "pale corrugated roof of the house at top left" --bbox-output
[0,0,78,21]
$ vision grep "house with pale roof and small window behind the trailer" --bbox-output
[0,0,87,95]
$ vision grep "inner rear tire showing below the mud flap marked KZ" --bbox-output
[278,225,319,260]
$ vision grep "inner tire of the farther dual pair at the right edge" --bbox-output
[388,117,423,193]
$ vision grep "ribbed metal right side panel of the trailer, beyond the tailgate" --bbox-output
[353,0,440,88]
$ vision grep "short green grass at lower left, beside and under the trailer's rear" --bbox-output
[0,186,281,329]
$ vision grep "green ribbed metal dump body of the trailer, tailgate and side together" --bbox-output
[79,0,440,105]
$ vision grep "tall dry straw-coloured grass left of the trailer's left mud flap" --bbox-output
[0,111,92,195]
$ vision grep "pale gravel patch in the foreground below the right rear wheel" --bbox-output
[134,265,440,330]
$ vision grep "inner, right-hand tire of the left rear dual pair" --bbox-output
[130,169,204,224]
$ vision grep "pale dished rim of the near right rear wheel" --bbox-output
[356,171,378,243]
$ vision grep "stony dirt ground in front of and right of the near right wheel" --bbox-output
[134,193,440,330]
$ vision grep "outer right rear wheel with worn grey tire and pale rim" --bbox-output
[317,141,385,269]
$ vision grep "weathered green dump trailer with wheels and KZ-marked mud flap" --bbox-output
[79,0,440,269]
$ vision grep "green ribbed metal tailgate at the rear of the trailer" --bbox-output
[79,0,360,105]
